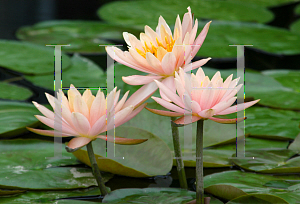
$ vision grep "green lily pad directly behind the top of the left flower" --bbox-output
[25,54,106,93]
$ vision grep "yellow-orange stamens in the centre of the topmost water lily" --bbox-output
[135,35,175,61]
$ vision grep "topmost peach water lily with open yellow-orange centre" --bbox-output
[106,7,211,100]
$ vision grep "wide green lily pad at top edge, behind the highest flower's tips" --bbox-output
[98,0,273,29]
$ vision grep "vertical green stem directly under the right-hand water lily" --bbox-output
[196,120,204,204]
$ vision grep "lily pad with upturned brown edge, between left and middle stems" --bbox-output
[73,127,172,177]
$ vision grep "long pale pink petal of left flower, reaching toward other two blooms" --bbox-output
[123,82,157,108]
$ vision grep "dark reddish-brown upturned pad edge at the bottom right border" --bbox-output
[227,194,288,204]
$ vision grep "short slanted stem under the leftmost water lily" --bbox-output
[86,141,107,196]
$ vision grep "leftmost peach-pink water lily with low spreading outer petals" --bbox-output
[27,85,153,151]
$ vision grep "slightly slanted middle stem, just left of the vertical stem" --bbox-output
[171,117,188,189]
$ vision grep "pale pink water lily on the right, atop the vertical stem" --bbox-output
[146,68,259,124]
